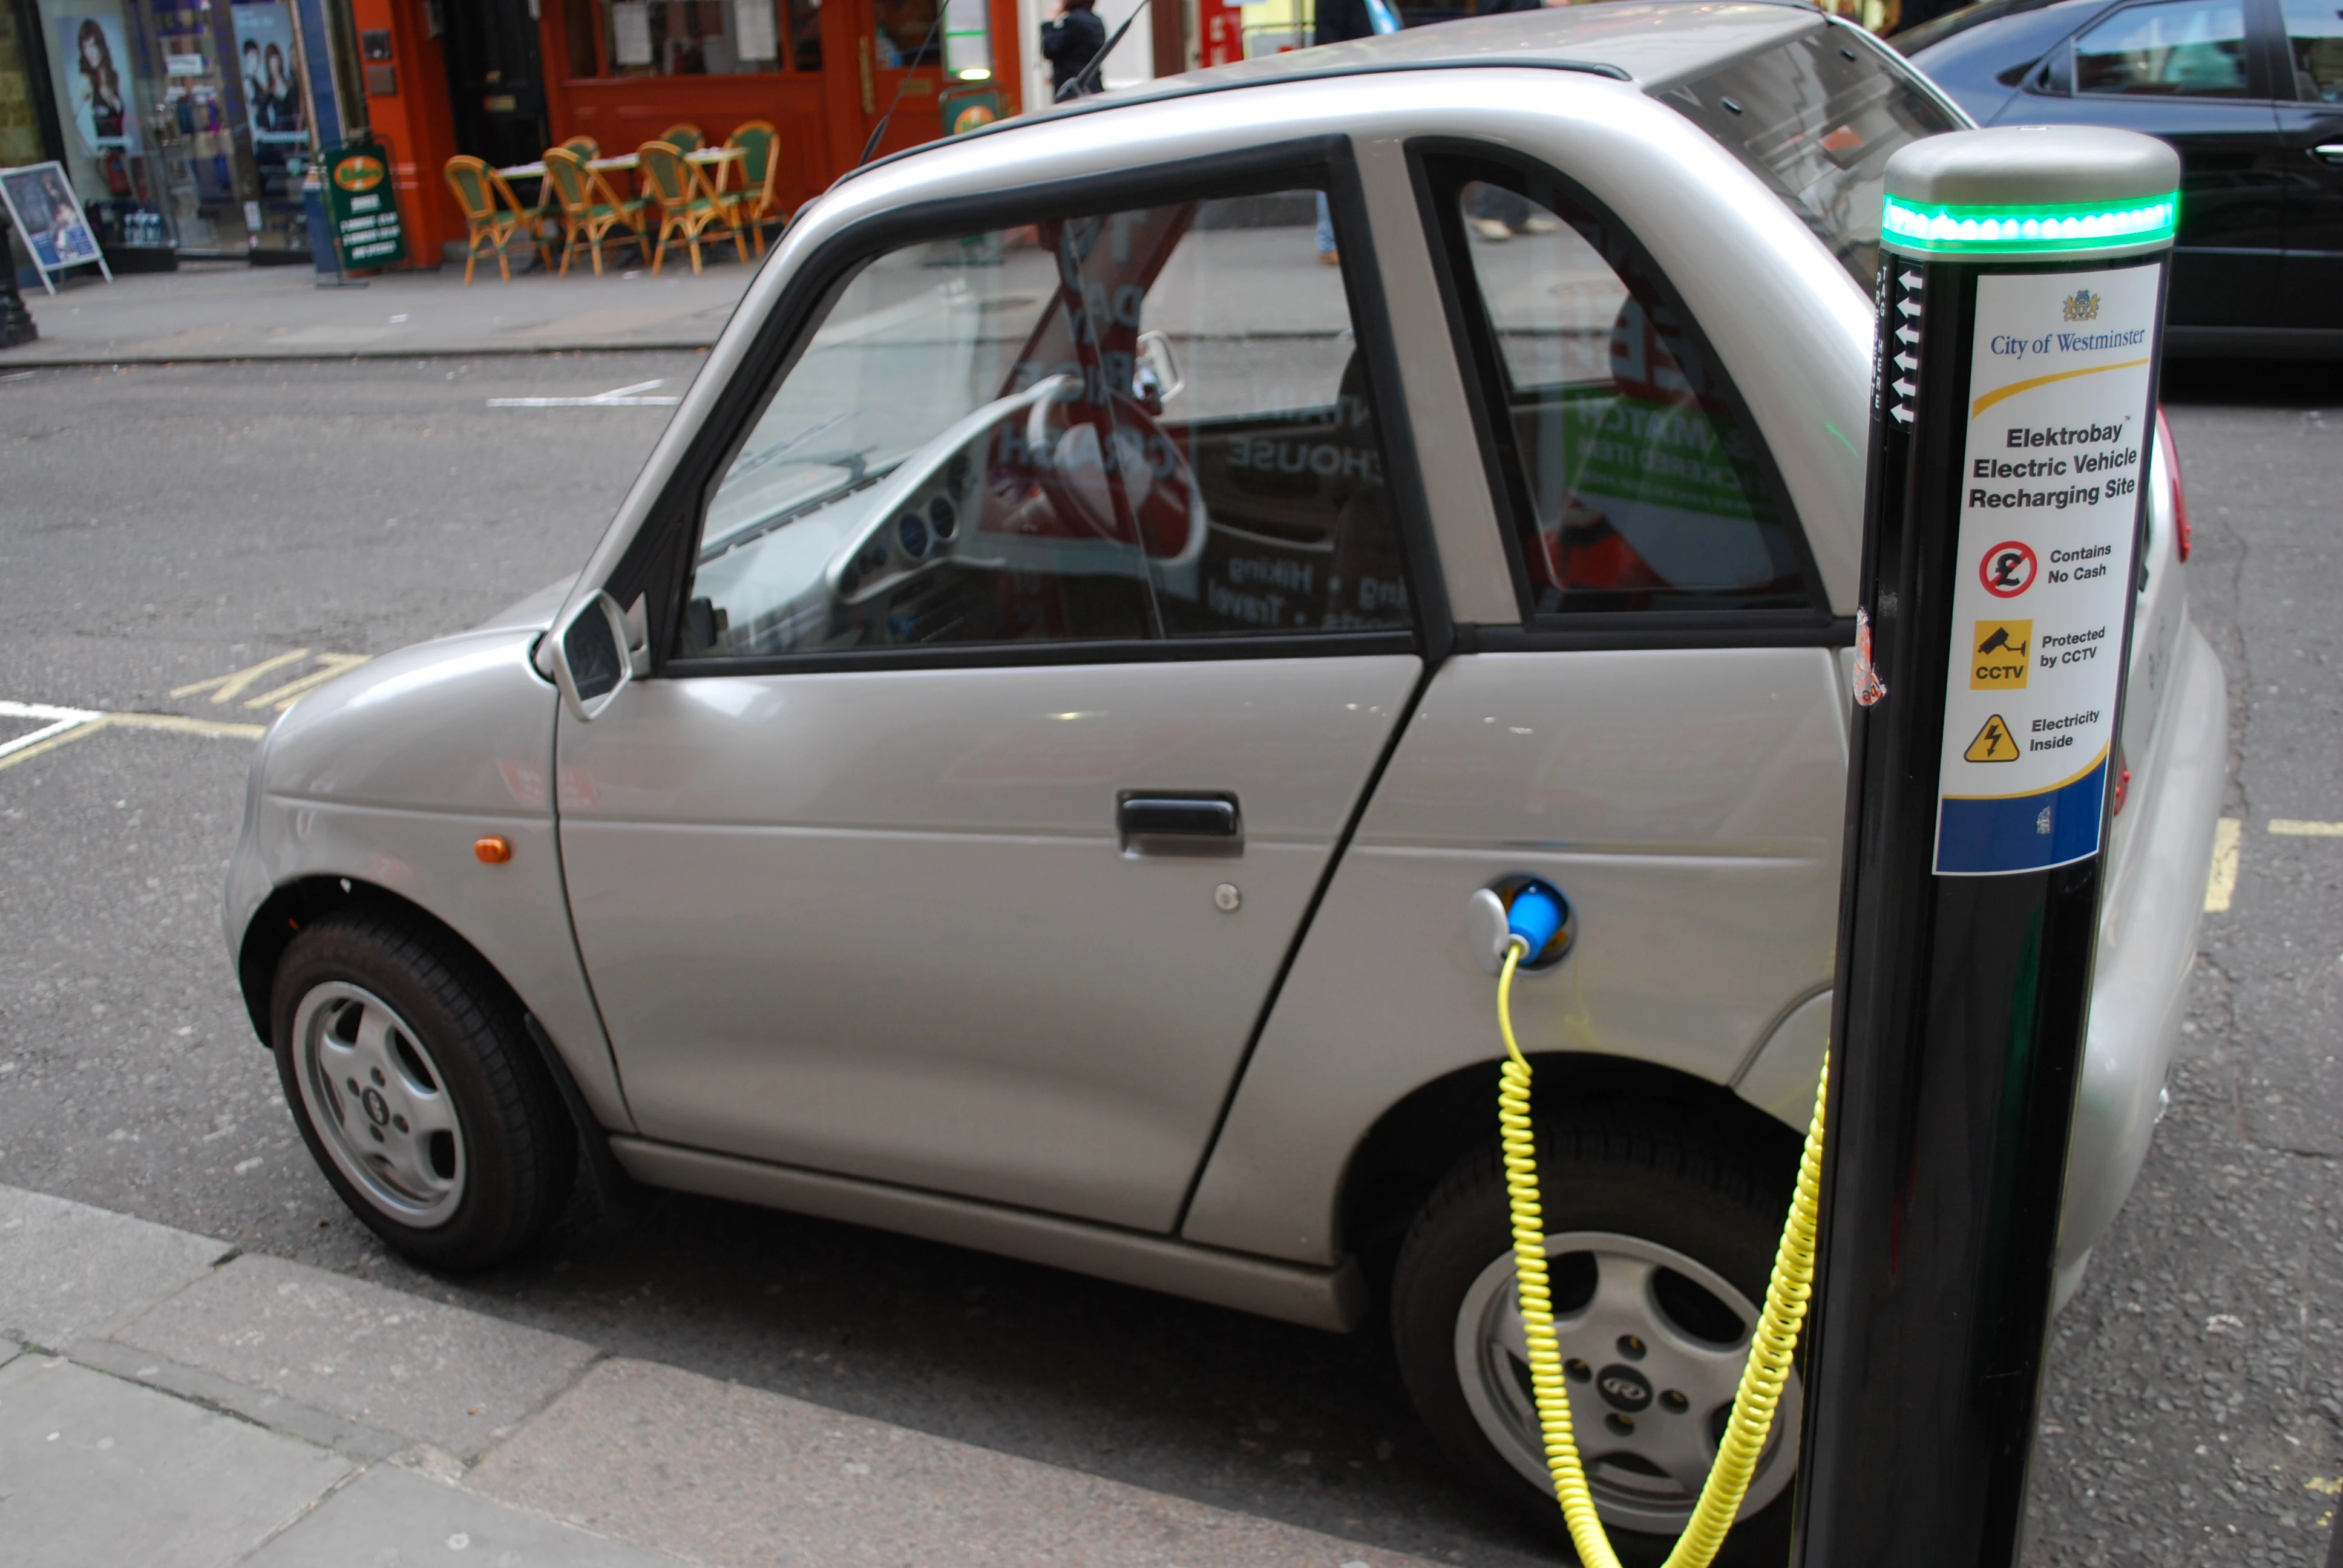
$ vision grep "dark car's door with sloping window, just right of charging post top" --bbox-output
[1994,0,2287,328]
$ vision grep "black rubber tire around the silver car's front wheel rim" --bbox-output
[269,907,577,1273]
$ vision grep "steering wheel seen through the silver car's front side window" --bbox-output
[1026,387,1204,563]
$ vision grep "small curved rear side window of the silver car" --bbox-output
[1443,164,1809,616]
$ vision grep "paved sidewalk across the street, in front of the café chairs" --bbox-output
[0,251,755,375]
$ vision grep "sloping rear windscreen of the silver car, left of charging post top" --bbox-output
[1659,28,1959,293]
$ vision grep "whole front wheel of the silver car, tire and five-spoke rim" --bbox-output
[272,909,577,1270]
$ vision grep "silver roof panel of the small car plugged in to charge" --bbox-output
[839,0,1827,183]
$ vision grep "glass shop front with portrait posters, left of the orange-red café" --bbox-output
[0,0,356,272]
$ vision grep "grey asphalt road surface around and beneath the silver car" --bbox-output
[0,354,2343,1568]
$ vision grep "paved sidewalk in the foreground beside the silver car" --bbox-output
[0,1186,1429,1568]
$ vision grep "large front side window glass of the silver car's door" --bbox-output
[682,190,1411,656]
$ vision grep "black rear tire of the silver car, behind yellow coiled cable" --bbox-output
[1392,1104,1797,1568]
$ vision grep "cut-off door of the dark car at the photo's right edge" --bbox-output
[2266,0,2343,330]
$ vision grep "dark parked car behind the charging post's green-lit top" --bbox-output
[1891,0,2343,356]
